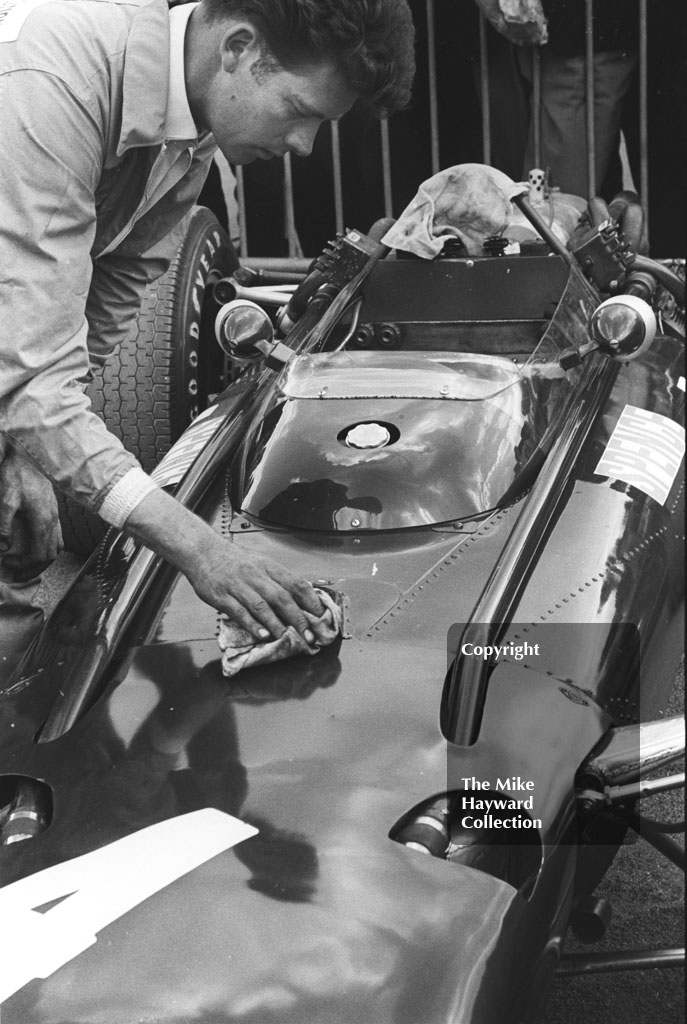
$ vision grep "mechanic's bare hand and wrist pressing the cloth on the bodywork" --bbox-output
[124,490,325,643]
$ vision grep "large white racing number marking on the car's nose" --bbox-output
[0,807,258,1002]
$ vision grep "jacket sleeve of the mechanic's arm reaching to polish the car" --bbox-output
[0,64,141,511]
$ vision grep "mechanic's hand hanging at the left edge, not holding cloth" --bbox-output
[0,440,62,583]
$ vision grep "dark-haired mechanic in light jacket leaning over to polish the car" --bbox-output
[0,0,414,672]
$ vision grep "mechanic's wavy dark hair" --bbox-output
[198,0,415,116]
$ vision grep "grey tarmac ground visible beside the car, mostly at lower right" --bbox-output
[33,554,685,1024]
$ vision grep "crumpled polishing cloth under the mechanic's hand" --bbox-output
[217,587,343,677]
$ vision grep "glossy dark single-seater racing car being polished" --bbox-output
[0,180,685,1024]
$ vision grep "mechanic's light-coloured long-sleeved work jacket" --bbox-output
[0,0,215,510]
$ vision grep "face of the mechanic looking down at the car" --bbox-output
[203,33,356,164]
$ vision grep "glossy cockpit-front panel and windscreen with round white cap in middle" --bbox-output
[239,353,541,531]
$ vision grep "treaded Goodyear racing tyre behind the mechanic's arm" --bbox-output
[57,206,239,555]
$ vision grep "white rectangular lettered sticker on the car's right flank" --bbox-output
[595,406,685,505]
